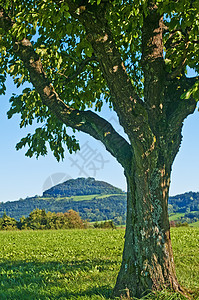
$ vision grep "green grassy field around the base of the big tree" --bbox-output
[0,228,199,300]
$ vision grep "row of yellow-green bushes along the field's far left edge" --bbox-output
[0,209,87,230]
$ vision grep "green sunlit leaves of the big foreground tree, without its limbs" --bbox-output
[0,0,199,160]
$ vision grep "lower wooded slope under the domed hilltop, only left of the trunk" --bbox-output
[0,194,126,225]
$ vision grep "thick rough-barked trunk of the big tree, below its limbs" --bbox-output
[114,151,187,298]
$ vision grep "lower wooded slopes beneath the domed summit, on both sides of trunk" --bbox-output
[0,192,199,225]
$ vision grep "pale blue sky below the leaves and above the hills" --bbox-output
[0,74,199,202]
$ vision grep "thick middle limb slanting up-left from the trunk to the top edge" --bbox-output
[59,0,147,142]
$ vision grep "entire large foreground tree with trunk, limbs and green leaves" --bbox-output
[0,0,199,297]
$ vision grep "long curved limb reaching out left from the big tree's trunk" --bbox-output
[0,7,133,168]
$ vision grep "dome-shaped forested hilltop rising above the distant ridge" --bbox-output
[43,177,123,197]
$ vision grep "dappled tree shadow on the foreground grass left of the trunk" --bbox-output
[0,259,118,300]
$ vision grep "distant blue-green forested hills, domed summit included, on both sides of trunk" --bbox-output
[0,178,199,224]
